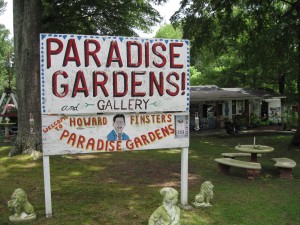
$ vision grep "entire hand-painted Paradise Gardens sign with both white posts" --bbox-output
[40,34,190,217]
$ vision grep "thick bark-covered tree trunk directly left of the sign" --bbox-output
[10,0,42,155]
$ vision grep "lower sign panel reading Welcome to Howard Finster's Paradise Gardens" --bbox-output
[42,113,189,155]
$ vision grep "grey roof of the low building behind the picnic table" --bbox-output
[190,85,262,102]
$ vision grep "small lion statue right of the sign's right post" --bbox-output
[193,181,214,207]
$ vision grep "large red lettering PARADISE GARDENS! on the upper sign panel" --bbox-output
[45,37,186,101]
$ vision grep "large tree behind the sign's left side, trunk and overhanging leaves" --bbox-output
[10,0,166,155]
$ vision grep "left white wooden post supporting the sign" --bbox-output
[43,155,52,217]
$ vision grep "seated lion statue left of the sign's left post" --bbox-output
[7,188,36,222]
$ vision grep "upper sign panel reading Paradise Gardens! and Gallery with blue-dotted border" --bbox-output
[40,34,190,115]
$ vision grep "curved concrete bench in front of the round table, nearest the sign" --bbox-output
[215,158,261,180]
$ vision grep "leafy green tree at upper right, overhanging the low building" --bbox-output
[172,0,300,147]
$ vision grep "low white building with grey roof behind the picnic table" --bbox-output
[190,85,285,129]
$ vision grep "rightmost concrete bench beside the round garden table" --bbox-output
[271,158,296,179]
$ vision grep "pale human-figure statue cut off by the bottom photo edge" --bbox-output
[148,187,180,225]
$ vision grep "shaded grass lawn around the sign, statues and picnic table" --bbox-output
[0,134,300,225]
